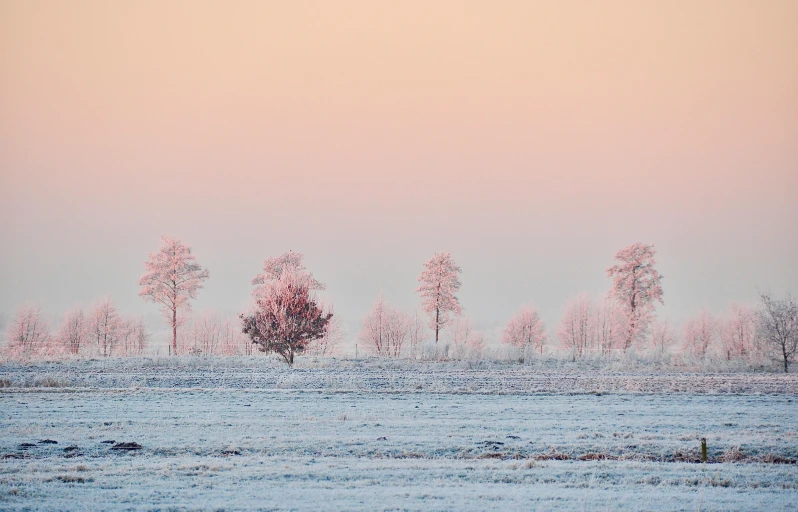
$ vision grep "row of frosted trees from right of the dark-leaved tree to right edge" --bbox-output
[359,243,798,372]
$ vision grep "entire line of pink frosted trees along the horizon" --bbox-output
[2,237,798,372]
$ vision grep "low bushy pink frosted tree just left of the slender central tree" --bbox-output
[358,294,411,357]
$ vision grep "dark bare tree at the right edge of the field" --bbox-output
[758,293,798,373]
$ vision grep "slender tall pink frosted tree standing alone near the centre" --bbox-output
[416,252,463,344]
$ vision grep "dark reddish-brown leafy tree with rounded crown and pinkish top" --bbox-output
[241,268,332,365]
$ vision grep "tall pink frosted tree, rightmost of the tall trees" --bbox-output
[606,242,664,350]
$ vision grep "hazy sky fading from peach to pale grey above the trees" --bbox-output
[0,0,798,350]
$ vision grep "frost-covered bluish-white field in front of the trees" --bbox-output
[0,358,798,511]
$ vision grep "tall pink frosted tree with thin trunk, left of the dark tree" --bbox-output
[139,236,210,354]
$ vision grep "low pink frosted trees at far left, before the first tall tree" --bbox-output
[6,297,150,360]
